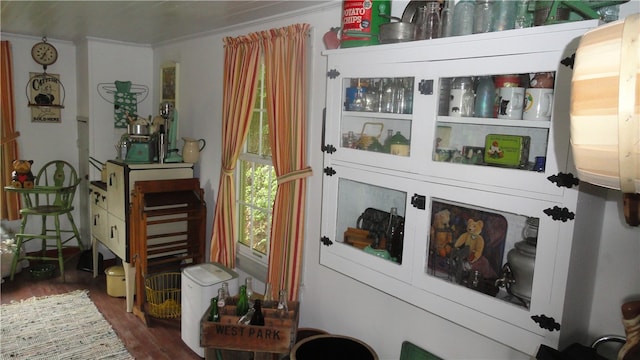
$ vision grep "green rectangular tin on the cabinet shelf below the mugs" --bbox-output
[484,134,531,167]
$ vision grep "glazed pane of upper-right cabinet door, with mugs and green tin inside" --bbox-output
[432,72,555,171]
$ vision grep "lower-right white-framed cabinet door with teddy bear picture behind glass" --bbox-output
[414,184,559,334]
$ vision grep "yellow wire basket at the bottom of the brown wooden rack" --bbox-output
[144,272,181,319]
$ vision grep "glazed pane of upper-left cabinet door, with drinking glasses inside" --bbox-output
[341,77,414,156]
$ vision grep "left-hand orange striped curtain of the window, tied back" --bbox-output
[210,34,260,268]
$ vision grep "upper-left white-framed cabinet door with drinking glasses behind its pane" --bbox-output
[325,65,436,172]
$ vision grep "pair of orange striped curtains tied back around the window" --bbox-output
[210,24,312,301]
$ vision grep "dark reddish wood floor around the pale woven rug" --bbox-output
[0,257,201,360]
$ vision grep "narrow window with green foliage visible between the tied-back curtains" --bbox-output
[236,63,277,267]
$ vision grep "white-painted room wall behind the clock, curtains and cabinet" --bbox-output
[2,1,640,359]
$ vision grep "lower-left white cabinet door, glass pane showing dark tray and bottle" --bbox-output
[322,166,416,281]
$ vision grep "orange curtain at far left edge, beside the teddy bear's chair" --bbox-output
[0,40,20,220]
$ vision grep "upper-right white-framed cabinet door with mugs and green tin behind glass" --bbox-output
[416,54,570,194]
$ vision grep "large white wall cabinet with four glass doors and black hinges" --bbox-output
[320,21,600,354]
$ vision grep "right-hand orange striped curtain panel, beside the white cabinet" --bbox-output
[261,24,311,301]
